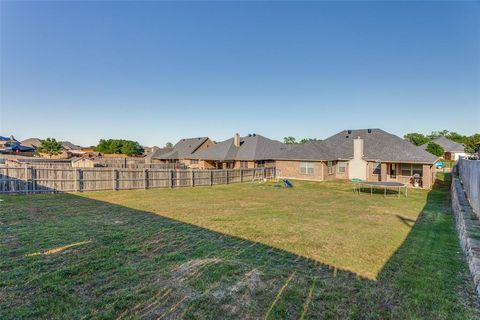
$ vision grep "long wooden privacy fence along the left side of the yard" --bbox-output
[0,166,275,194]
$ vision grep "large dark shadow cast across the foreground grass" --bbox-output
[0,176,476,319]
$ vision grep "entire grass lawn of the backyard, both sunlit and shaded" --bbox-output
[0,176,480,319]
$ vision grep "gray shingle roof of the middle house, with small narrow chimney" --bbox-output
[192,135,287,161]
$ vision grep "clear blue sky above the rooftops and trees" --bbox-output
[0,1,480,145]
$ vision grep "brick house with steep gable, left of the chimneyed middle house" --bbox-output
[151,137,214,169]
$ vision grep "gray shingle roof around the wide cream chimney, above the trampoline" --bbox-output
[321,129,438,164]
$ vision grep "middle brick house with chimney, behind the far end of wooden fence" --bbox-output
[190,133,287,169]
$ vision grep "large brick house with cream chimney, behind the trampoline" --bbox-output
[276,129,438,188]
